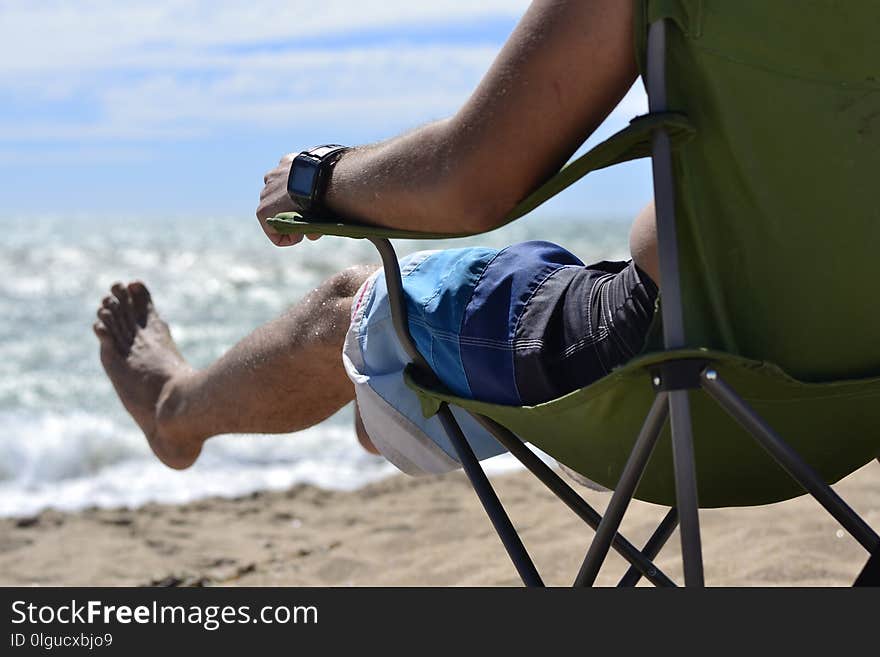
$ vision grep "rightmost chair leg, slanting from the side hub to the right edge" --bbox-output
[700,369,880,554]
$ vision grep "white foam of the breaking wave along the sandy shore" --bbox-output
[0,404,393,515]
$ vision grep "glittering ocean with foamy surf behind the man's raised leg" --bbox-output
[0,214,628,516]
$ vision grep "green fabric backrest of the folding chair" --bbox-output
[636,0,880,381]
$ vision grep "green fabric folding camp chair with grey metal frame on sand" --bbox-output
[270,0,880,586]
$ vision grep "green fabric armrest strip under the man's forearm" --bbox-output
[267,112,694,239]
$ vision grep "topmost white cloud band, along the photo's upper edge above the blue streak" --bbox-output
[0,0,529,76]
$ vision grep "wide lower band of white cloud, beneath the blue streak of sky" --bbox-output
[0,46,495,140]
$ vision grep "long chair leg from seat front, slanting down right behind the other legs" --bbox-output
[471,413,675,586]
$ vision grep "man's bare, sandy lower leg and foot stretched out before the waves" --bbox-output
[94,267,375,468]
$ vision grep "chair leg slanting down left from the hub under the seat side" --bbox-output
[574,392,668,586]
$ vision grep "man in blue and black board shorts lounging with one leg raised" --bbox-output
[94,0,658,473]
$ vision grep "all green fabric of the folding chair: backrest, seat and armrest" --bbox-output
[273,0,880,507]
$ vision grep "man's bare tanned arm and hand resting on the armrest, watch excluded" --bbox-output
[257,0,637,244]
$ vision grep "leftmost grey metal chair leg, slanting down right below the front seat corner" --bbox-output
[437,403,544,586]
